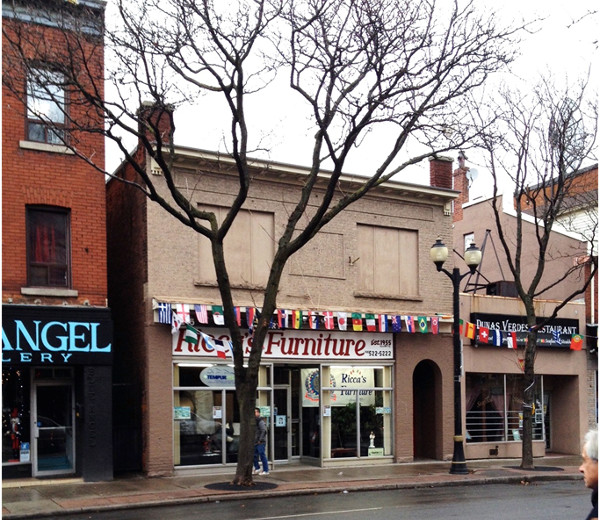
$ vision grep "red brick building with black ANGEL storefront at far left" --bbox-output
[2,0,113,481]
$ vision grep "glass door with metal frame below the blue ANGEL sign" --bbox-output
[32,382,75,477]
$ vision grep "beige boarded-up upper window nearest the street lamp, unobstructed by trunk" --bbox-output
[356,224,419,298]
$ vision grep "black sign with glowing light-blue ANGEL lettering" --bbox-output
[2,305,112,365]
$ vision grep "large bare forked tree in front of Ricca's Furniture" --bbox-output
[3,0,523,484]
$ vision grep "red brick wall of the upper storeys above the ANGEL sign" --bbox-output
[2,12,107,306]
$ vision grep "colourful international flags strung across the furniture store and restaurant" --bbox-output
[154,302,583,357]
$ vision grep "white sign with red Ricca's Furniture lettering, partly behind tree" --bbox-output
[173,329,394,361]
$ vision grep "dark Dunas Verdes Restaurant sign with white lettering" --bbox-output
[471,313,579,348]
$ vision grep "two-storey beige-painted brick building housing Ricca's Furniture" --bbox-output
[107,127,468,475]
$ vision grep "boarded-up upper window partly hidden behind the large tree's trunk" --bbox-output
[197,206,274,289]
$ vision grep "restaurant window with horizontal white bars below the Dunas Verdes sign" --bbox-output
[465,373,545,442]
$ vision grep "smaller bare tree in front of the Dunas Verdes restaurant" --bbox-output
[478,79,598,469]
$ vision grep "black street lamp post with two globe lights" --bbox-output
[429,239,481,475]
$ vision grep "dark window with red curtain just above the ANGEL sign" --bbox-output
[27,207,71,287]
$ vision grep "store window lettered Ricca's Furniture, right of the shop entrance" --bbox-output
[322,366,393,458]
